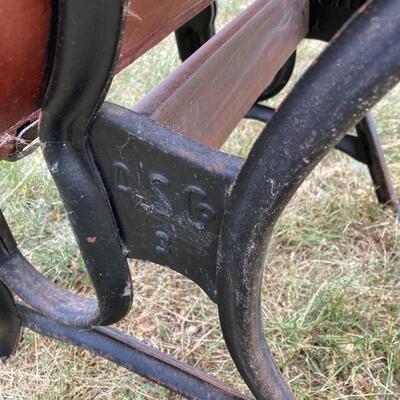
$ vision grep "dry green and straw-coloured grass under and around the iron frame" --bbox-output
[0,0,400,400]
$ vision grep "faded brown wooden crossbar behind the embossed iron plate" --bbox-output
[134,0,308,148]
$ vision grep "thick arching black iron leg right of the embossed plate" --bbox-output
[217,0,400,399]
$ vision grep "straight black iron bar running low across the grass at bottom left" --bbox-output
[18,304,250,400]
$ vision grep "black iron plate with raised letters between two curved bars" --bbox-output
[90,104,242,300]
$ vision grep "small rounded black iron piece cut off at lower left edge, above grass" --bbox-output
[0,280,21,361]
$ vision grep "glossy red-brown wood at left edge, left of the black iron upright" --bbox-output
[0,0,51,158]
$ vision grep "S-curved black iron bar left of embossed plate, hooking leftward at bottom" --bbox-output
[0,0,132,327]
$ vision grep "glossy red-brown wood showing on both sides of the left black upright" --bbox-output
[0,0,212,159]
